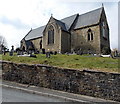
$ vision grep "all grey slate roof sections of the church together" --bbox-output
[25,7,103,40]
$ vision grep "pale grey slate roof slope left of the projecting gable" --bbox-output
[25,26,45,40]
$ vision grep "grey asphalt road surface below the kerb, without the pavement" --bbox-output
[2,87,69,102]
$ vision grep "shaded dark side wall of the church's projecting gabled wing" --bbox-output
[61,31,70,53]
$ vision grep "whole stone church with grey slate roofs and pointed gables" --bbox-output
[21,7,110,54]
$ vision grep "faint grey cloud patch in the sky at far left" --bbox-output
[0,16,30,29]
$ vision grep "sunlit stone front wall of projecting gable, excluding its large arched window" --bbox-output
[42,19,61,52]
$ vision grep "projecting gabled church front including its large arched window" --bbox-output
[42,16,62,52]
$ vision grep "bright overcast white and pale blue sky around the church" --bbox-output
[0,0,118,49]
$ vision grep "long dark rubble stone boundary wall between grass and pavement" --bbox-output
[2,62,120,101]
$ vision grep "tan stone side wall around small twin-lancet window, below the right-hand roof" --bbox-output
[71,25,100,53]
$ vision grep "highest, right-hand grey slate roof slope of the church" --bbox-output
[74,8,102,29]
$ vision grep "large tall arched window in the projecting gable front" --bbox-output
[48,25,54,44]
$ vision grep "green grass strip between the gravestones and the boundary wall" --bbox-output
[2,54,119,72]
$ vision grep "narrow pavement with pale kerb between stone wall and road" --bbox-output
[1,81,120,104]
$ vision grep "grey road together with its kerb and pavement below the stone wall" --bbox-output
[0,80,120,104]
